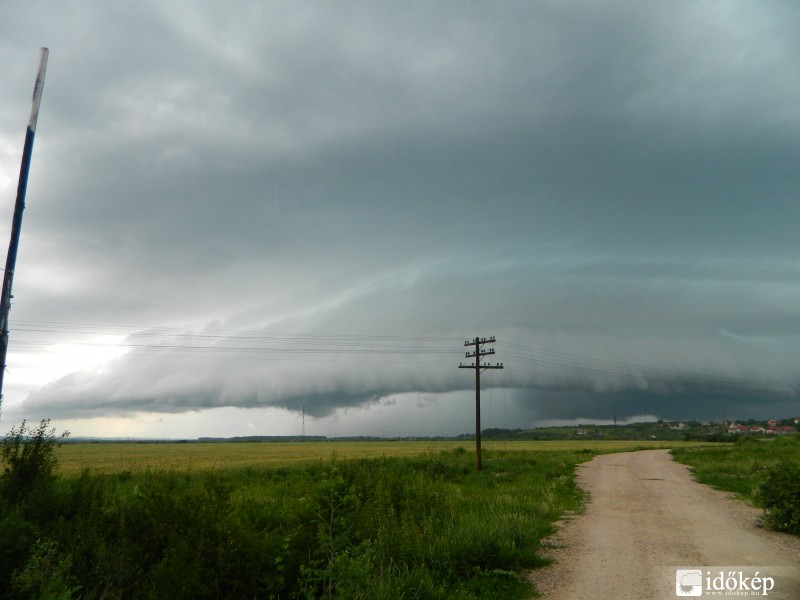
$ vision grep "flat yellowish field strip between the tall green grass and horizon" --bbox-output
[57,440,697,475]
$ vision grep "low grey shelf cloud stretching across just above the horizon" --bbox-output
[17,255,800,418]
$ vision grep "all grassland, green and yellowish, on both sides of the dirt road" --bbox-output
[0,422,800,600]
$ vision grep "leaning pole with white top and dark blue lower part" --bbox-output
[0,48,50,415]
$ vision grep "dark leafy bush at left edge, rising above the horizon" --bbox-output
[0,419,69,504]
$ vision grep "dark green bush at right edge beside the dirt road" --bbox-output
[758,461,800,535]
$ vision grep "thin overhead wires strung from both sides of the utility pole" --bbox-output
[7,321,800,390]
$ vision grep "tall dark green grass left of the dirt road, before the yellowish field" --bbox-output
[0,447,594,600]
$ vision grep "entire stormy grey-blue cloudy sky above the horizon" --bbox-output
[0,0,800,437]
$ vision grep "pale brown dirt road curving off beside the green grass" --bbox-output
[531,450,800,600]
